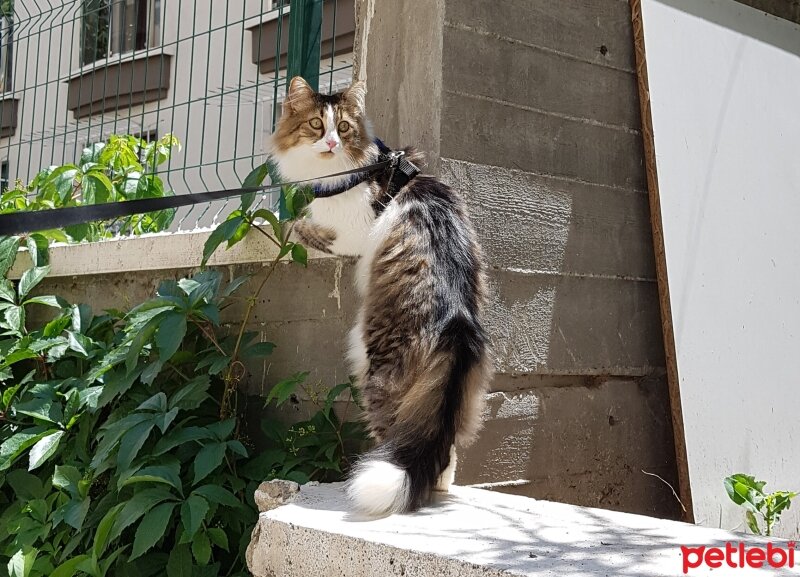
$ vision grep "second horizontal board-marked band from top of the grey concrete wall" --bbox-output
[443,24,640,130]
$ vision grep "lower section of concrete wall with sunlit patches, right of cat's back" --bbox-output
[442,159,680,518]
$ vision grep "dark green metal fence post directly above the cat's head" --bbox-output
[279,0,323,218]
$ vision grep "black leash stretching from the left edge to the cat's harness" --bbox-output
[0,155,410,236]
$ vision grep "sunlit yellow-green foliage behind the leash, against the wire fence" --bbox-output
[0,134,180,242]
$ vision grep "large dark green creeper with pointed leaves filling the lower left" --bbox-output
[0,157,363,577]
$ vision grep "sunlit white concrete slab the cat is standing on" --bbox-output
[247,483,798,577]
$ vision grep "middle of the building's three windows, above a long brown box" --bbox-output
[81,0,163,65]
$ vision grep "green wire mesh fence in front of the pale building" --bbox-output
[0,0,355,230]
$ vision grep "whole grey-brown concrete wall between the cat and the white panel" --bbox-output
[358,0,679,516]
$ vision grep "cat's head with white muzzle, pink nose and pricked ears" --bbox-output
[272,76,372,166]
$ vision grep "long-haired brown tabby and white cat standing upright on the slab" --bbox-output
[270,77,490,516]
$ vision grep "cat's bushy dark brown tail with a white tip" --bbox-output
[347,315,487,516]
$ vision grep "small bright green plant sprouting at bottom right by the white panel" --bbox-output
[724,473,797,537]
